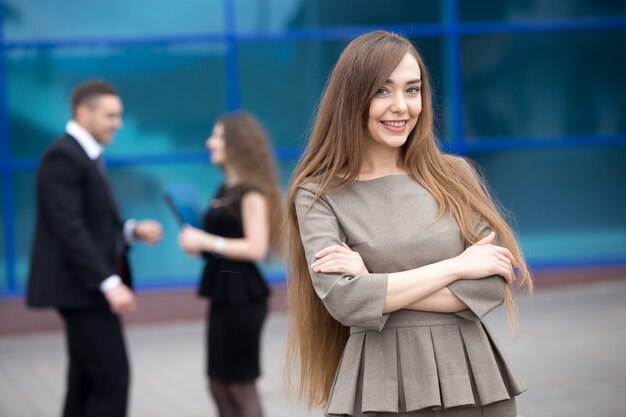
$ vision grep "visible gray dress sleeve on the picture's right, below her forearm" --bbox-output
[448,222,506,320]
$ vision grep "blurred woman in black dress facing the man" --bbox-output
[179,112,282,417]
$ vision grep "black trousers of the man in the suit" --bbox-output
[59,310,130,417]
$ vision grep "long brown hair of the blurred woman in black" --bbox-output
[216,111,283,252]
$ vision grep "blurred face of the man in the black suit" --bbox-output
[76,95,123,145]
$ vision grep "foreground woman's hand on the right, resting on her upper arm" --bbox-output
[454,232,517,284]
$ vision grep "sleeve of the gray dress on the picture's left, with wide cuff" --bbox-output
[295,188,388,330]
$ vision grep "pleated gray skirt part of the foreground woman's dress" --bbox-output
[326,310,526,417]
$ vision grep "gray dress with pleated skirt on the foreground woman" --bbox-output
[295,175,526,417]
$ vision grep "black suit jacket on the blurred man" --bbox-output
[27,134,130,308]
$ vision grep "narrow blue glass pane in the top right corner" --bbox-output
[459,0,626,22]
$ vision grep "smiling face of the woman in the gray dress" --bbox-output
[367,54,422,148]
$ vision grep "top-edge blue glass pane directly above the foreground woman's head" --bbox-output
[235,0,441,32]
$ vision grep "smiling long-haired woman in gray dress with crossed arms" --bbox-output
[287,32,532,417]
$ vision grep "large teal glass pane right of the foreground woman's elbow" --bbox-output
[470,147,626,263]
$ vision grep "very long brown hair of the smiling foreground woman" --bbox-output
[286,31,532,406]
